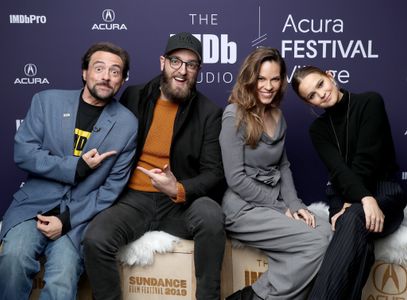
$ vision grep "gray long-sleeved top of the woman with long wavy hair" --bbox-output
[219,104,306,216]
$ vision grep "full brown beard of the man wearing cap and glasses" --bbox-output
[160,68,196,103]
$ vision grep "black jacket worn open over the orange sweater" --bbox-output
[120,76,226,203]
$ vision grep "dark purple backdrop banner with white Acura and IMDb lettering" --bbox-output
[0,0,407,219]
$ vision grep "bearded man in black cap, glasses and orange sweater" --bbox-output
[84,32,225,300]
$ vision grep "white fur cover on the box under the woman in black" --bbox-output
[308,202,407,266]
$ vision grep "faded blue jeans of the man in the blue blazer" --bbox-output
[0,220,83,300]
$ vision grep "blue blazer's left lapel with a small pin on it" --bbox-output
[59,90,81,155]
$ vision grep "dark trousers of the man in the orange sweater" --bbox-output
[84,190,226,300]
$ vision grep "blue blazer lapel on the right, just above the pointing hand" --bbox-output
[82,99,117,154]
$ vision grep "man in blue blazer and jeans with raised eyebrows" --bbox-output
[0,43,138,300]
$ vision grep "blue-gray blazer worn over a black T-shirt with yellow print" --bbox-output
[0,90,138,249]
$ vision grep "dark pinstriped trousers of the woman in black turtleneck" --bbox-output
[308,182,406,300]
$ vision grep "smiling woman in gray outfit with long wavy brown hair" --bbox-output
[220,48,331,300]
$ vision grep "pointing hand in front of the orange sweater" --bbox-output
[137,165,178,198]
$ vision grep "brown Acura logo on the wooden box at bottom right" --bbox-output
[373,263,407,295]
